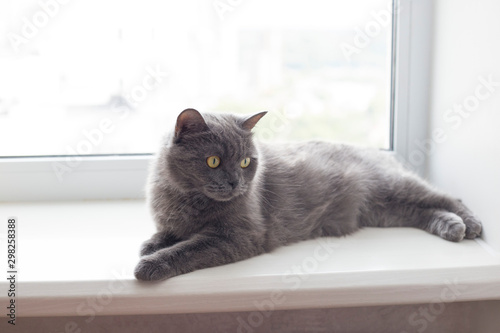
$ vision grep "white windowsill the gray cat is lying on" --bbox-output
[0,200,500,317]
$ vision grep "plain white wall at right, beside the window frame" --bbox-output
[428,0,500,251]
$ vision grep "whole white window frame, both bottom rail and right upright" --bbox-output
[0,0,433,202]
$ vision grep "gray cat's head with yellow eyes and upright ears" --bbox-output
[165,109,267,201]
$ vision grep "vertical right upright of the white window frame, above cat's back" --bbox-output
[392,0,434,177]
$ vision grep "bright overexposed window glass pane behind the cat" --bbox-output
[0,0,392,156]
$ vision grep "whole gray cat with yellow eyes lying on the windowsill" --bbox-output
[135,109,481,280]
